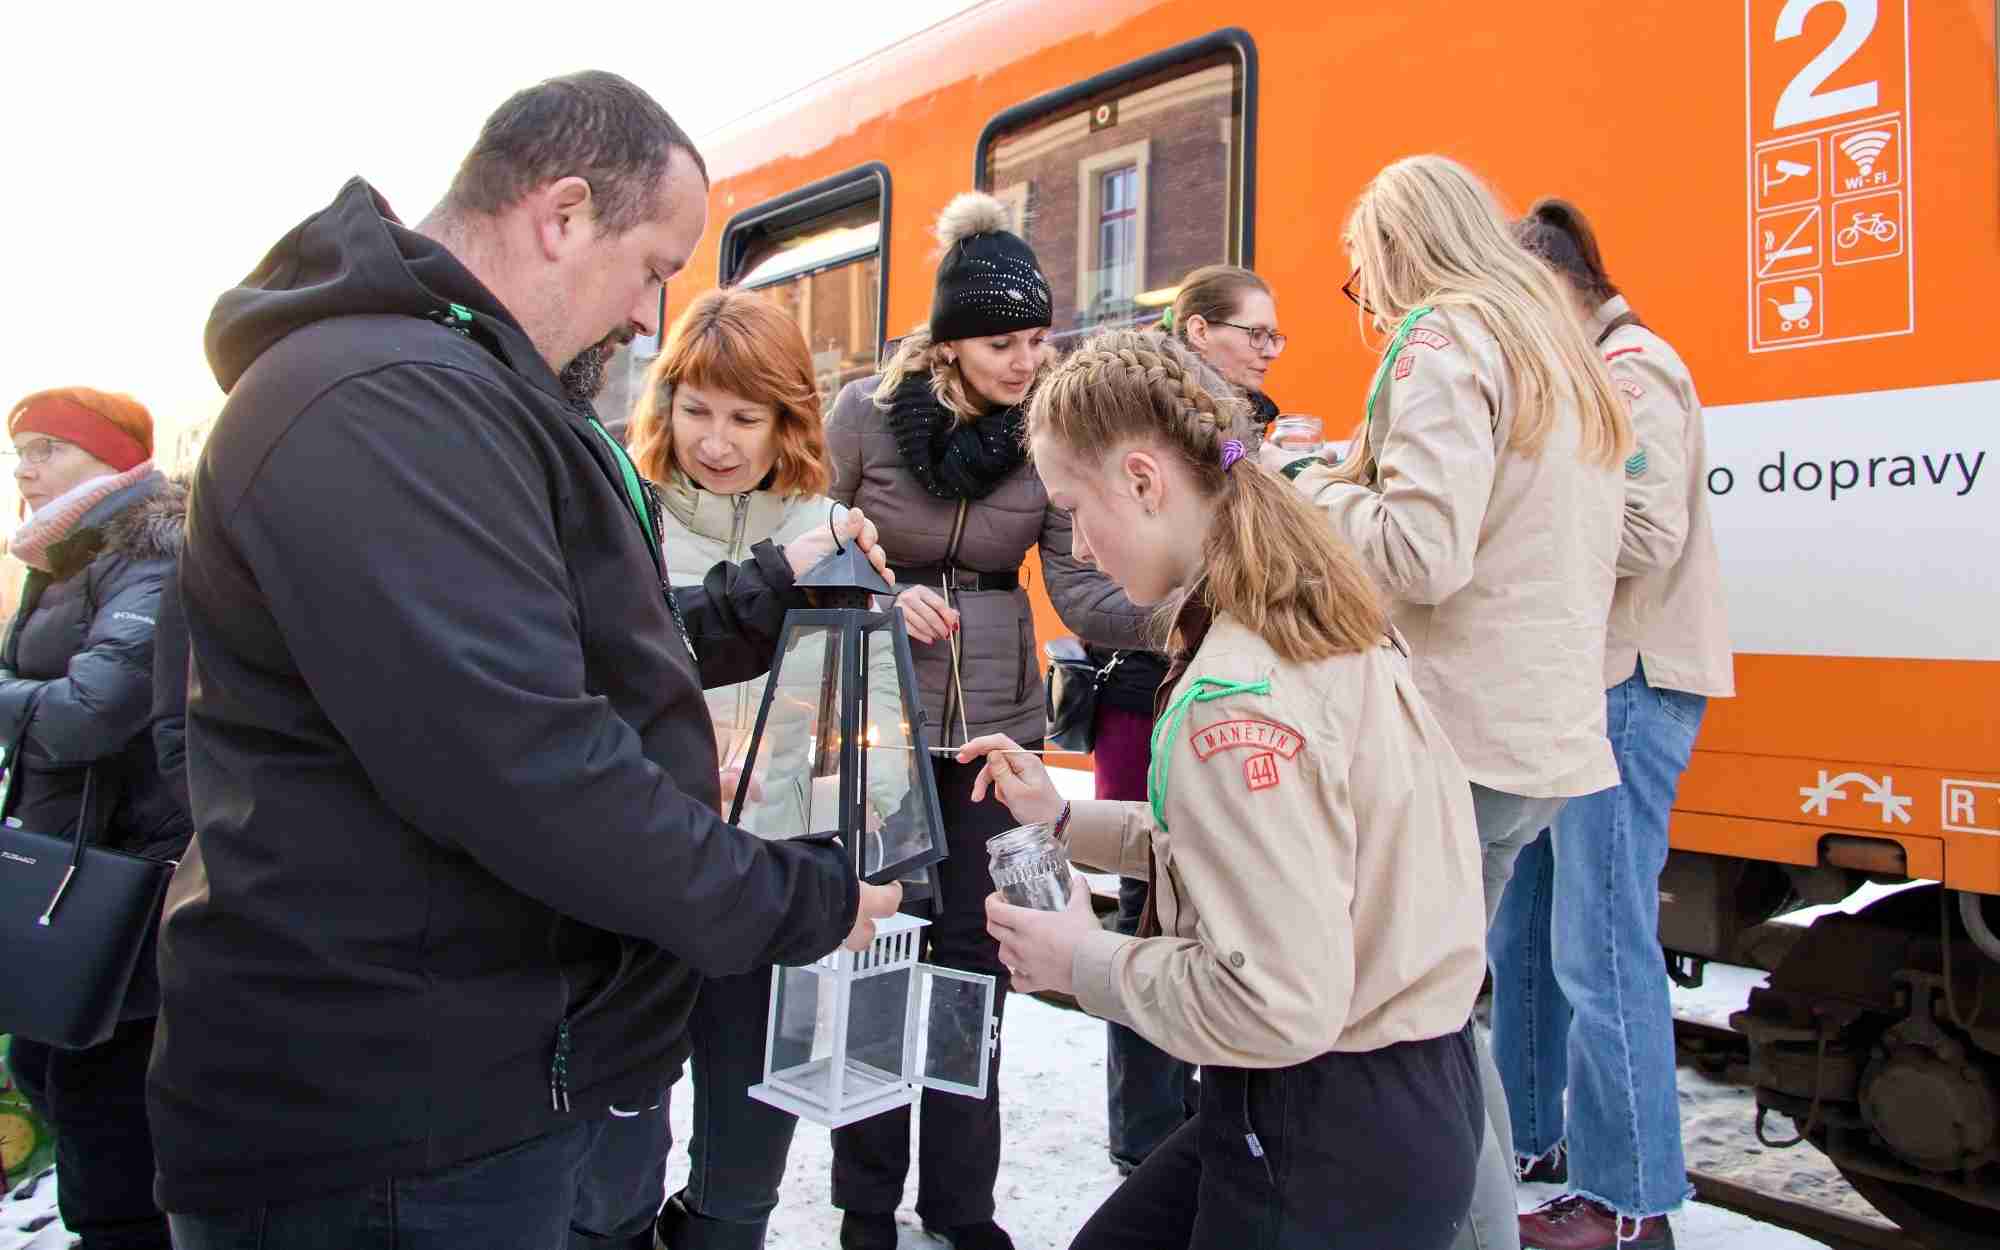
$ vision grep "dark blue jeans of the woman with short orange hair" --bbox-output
[662,968,798,1250]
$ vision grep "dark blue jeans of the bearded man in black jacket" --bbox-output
[168,1120,650,1250]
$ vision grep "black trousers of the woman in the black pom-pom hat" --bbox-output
[834,742,1040,1228]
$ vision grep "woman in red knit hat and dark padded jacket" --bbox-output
[0,386,190,1250]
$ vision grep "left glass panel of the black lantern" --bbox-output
[736,624,842,838]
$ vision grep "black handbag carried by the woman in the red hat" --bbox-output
[0,704,174,1050]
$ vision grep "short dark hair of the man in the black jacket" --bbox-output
[444,70,708,234]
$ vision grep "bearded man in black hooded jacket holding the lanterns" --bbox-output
[148,74,896,1250]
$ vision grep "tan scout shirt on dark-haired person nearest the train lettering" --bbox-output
[1592,296,1736,698]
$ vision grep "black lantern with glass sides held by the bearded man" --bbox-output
[730,542,944,886]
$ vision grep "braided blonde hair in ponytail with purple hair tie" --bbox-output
[1028,330,1388,662]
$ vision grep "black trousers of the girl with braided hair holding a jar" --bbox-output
[1070,1030,1486,1250]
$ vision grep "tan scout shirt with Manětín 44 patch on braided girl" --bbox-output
[1068,618,1488,1068]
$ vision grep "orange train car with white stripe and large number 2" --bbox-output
[634,0,2000,1246]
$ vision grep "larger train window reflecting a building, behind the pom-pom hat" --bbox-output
[976,30,1256,342]
